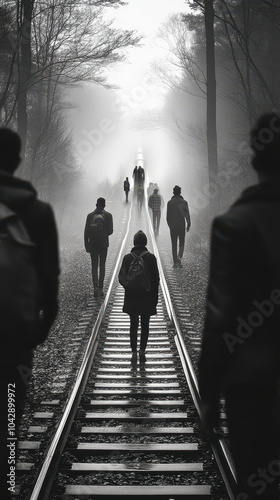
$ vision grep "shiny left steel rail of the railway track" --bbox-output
[30,203,133,500]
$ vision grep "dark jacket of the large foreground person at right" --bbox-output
[199,181,280,404]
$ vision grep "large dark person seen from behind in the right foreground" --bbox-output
[199,113,280,500]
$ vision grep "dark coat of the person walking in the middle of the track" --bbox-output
[119,246,159,316]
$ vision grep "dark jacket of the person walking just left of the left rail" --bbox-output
[84,208,113,252]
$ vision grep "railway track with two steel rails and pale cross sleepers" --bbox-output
[18,202,233,500]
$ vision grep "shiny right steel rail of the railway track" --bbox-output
[145,199,237,500]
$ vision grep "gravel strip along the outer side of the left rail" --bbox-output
[17,203,129,500]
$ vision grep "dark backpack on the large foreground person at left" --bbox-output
[0,203,39,347]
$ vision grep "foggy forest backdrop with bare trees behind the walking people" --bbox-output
[0,0,280,251]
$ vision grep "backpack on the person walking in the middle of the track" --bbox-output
[127,250,151,293]
